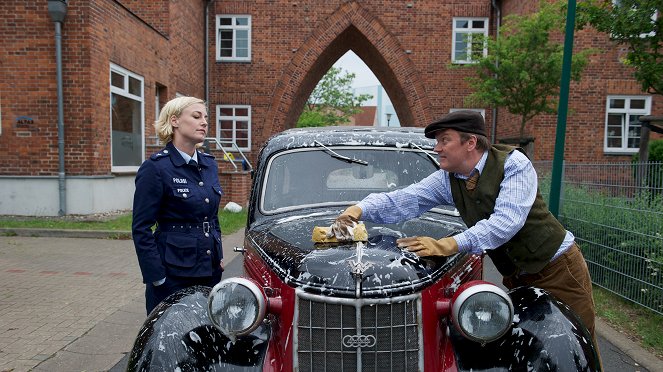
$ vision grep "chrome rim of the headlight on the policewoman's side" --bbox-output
[207,277,267,339]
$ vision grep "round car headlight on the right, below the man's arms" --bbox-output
[451,282,513,343]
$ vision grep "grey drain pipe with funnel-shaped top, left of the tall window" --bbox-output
[48,0,67,216]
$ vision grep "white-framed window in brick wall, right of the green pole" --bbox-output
[603,96,651,154]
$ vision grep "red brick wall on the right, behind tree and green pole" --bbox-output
[497,0,663,162]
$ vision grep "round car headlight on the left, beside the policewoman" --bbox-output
[207,278,267,339]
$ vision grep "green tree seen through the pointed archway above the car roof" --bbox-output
[297,67,373,127]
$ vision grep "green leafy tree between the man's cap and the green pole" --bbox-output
[467,1,592,144]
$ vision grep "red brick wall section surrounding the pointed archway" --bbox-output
[209,0,491,169]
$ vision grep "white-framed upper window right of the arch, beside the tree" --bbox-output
[451,18,488,63]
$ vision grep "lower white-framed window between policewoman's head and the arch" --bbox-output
[216,105,251,151]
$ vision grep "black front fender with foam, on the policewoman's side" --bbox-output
[127,286,271,371]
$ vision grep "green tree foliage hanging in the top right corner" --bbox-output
[578,0,663,94]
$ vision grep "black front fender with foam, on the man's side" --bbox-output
[449,287,601,371]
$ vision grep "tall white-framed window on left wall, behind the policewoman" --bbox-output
[110,64,145,172]
